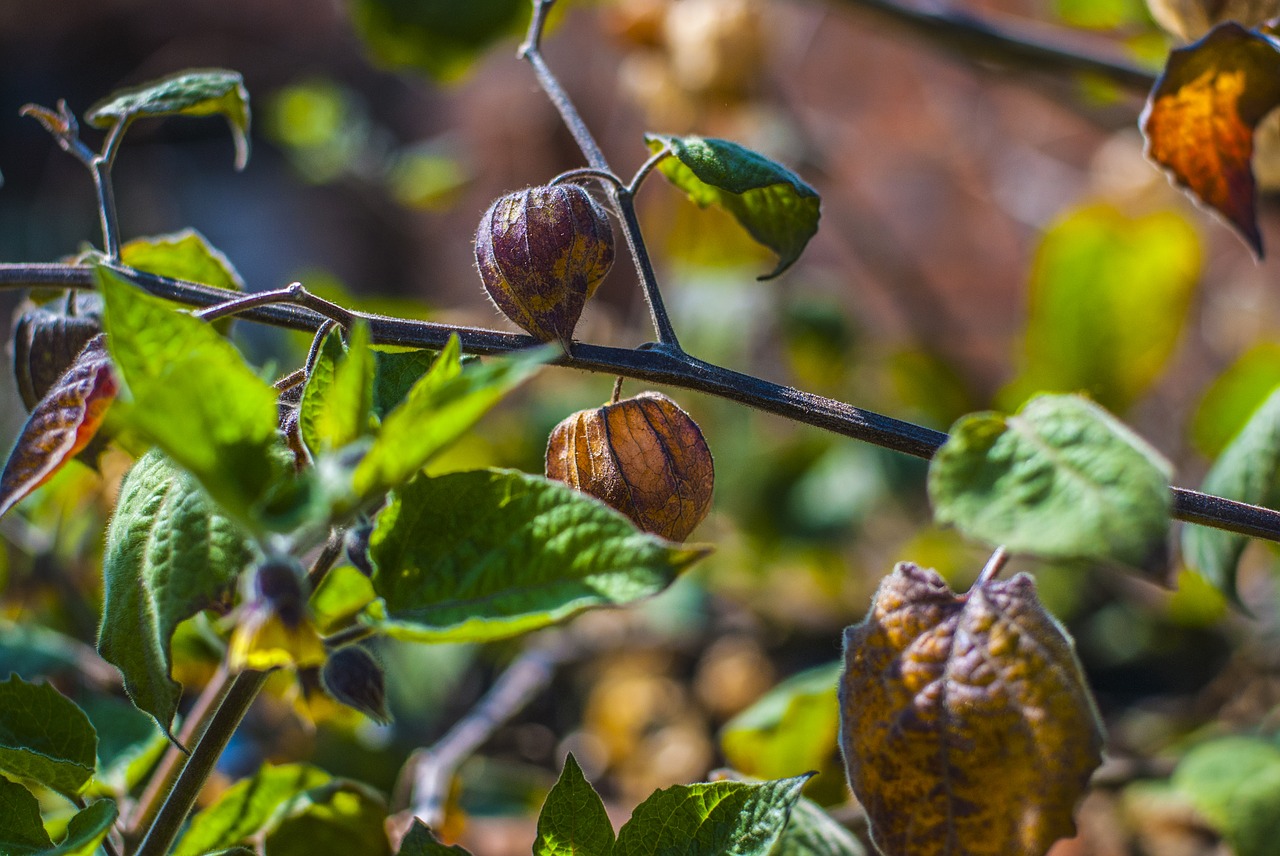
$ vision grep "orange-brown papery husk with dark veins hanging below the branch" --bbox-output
[547,393,716,541]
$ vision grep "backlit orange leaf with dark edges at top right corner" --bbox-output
[1140,20,1280,257]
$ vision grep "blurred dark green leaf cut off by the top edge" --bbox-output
[351,0,530,81]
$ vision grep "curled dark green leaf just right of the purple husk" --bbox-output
[645,134,820,279]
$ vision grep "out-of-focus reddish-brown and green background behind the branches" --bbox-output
[0,0,1280,853]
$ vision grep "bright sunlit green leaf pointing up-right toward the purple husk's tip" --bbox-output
[352,337,557,496]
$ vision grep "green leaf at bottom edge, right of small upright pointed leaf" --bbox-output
[613,775,809,856]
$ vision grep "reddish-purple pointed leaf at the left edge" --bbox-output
[0,334,118,517]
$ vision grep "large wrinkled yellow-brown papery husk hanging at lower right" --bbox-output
[840,562,1103,856]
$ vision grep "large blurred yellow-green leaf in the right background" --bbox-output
[1002,205,1203,412]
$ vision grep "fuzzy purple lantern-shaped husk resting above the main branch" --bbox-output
[476,184,613,345]
